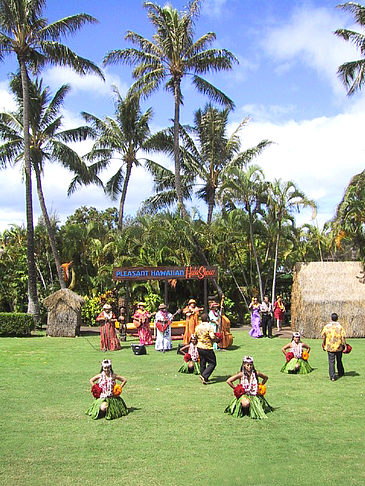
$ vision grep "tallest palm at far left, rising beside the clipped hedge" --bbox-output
[0,0,103,318]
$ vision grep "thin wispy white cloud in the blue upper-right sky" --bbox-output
[261,7,359,94]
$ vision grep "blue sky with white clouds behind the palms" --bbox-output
[0,0,365,231]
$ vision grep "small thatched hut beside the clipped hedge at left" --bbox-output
[43,289,85,337]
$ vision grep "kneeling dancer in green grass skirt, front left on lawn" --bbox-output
[86,359,128,420]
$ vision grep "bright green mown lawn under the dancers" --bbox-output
[0,330,365,486]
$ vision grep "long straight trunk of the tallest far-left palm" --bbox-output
[18,56,40,320]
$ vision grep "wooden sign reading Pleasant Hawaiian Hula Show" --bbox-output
[113,265,218,280]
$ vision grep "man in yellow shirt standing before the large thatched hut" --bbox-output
[321,312,346,381]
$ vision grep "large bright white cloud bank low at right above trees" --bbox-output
[233,100,365,228]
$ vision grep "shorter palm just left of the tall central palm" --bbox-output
[75,88,153,230]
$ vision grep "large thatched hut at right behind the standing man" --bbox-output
[291,262,365,338]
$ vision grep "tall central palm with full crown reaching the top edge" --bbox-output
[104,0,238,216]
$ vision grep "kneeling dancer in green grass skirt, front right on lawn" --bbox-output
[225,356,273,419]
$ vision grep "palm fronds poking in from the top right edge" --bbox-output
[335,2,365,96]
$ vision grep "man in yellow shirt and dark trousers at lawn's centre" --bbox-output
[195,314,219,385]
